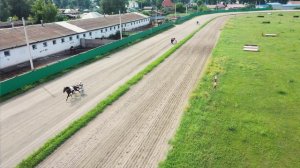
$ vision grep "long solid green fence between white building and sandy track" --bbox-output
[0,23,173,96]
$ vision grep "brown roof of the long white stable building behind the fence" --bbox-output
[0,13,147,50]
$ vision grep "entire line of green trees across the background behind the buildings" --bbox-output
[0,0,298,22]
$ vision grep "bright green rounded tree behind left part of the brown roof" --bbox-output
[31,0,57,23]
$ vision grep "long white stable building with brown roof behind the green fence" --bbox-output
[0,13,150,69]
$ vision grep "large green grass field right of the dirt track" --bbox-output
[160,12,300,168]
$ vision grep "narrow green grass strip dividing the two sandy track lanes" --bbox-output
[17,16,218,168]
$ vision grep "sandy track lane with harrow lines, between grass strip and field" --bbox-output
[39,16,228,168]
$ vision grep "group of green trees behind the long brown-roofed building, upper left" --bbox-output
[0,0,128,22]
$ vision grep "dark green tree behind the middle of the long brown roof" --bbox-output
[100,0,128,14]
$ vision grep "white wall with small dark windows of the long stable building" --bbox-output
[0,18,150,69]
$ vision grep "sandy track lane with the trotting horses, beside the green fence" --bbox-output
[0,14,230,168]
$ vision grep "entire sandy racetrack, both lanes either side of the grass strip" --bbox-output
[6,11,288,168]
